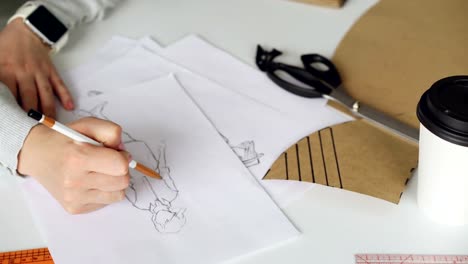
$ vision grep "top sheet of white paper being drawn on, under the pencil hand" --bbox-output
[23,76,298,264]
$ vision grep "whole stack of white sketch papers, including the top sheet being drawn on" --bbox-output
[23,36,347,263]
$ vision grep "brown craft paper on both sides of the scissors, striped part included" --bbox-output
[265,0,468,203]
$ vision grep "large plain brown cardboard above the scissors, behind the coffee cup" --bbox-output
[333,0,468,127]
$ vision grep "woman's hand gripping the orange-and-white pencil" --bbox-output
[18,117,130,214]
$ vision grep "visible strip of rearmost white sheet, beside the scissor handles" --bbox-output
[147,35,326,119]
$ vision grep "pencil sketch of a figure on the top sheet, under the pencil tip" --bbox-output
[75,102,186,233]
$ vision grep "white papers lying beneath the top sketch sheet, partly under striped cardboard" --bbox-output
[67,35,350,206]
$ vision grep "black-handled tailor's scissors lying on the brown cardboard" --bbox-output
[256,45,419,143]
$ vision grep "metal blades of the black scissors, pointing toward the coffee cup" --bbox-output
[325,87,419,143]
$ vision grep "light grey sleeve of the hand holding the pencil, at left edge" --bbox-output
[0,83,37,174]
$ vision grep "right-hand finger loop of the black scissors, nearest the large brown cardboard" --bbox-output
[301,54,341,88]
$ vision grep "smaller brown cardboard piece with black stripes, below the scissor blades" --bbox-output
[264,119,418,203]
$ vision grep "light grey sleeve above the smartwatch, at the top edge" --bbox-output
[34,0,123,29]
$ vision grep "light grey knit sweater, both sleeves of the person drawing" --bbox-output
[0,0,120,174]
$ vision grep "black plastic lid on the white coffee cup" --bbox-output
[417,76,468,146]
